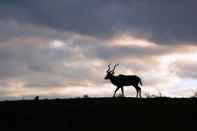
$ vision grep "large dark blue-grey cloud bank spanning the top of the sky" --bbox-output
[0,0,197,43]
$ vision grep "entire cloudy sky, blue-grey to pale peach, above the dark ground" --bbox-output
[0,0,197,99]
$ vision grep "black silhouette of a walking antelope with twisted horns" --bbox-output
[105,64,142,98]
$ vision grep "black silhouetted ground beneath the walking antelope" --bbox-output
[0,98,197,131]
